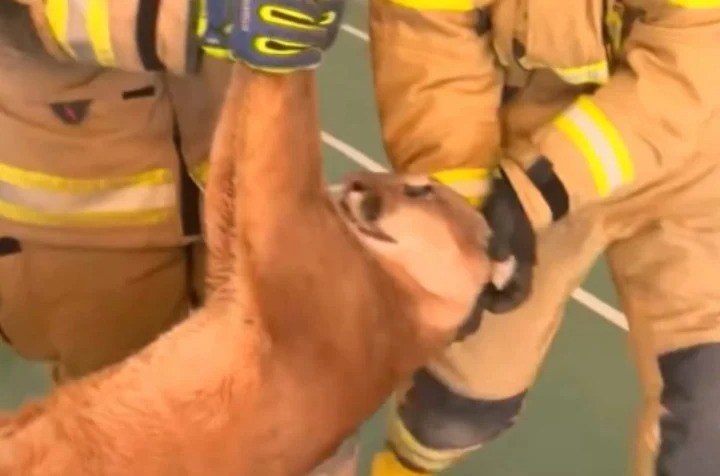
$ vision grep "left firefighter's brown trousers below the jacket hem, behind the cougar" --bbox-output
[0,238,202,380]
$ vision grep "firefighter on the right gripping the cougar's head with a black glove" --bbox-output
[370,0,720,476]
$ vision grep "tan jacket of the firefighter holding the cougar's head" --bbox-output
[370,0,720,227]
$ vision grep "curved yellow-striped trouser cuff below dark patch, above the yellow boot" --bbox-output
[388,412,482,473]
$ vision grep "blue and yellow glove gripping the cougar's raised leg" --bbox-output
[198,0,345,73]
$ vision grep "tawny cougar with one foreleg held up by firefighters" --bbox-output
[0,66,506,476]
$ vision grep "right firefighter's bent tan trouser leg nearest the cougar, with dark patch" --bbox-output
[372,210,606,476]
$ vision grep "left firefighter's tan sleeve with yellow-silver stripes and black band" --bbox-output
[13,0,201,74]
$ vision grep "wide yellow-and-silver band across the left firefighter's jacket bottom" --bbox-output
[0,164,177,226]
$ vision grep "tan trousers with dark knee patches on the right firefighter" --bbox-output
[378,128,720,476]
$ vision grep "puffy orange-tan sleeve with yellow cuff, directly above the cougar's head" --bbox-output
[370,0,501,202]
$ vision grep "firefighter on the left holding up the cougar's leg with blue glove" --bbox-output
[0,0,343,381]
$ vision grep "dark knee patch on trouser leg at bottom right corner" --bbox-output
[656,344,720,476]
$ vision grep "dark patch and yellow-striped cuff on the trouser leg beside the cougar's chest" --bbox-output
[390,369,527,472]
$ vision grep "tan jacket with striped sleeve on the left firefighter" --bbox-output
[0,0,229,247]
